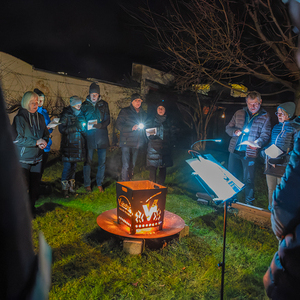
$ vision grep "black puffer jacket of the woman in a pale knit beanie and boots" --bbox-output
[58,106,86,162]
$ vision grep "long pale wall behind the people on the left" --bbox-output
[0,52,136,150]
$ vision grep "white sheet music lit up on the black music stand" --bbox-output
[186,154,245,202]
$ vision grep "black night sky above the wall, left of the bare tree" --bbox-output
[0,0,162,82]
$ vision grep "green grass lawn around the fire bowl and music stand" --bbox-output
[33,150,278,299]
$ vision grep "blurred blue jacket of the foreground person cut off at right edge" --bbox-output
[264,133,300,299]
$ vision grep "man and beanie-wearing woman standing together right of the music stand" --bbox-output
[226,92,300,209]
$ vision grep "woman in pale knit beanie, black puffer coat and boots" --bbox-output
[58,96,86,198]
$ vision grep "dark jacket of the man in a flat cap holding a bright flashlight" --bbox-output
[116,104,146,148]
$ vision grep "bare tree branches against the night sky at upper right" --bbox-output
[141,0,300,92]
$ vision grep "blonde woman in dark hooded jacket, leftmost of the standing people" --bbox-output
[13,91,49,215]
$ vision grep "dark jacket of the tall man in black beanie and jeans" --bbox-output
[81,96,110,149]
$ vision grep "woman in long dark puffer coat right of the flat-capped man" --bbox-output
[147,101,174,185]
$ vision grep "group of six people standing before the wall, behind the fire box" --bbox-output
[13,82,173,213]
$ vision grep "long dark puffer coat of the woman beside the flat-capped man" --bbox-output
[147,115,174,167]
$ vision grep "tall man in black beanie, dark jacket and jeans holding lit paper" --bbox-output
[81,82,110,192]
